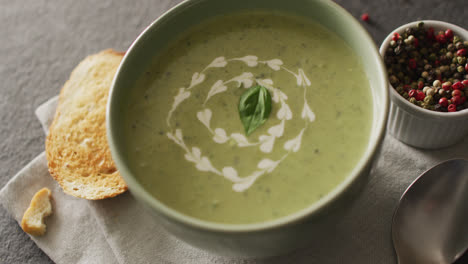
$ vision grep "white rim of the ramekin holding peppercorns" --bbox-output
[379,20,468,120]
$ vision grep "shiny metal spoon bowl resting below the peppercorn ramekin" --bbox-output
[392,159,468,264]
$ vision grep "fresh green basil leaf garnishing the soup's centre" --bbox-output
[239,85,271,135]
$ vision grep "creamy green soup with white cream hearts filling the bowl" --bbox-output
[123,11,372,224]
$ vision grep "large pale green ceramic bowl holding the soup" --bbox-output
[107,0,389,257]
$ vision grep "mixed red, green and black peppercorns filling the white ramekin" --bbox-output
[384,22,468,112]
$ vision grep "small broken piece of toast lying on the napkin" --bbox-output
[21,188,52,236]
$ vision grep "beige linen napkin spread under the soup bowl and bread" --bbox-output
[0,98,468,264]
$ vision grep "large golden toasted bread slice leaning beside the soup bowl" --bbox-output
[46,50,127,200]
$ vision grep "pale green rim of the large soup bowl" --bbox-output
[106,0,389,234]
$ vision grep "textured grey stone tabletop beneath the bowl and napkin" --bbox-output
[0,0,468,263]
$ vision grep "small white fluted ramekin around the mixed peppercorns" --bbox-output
[380,20,468,149]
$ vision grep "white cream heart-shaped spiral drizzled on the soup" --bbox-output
[166,55,315,192]
